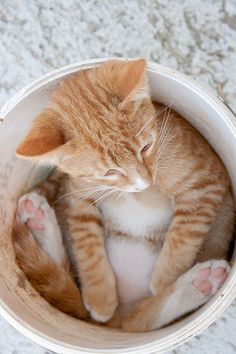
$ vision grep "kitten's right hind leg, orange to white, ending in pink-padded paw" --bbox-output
[122,260,230,332]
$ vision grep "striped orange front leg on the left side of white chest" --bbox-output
[67,197,118,322]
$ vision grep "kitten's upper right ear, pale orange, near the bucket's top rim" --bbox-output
[105,59,150,108]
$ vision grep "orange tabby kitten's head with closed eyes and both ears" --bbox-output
[17,60,157,192]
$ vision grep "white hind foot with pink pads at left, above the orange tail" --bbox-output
[17,192,65,263]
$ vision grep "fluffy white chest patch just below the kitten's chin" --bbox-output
[100,187,172,238]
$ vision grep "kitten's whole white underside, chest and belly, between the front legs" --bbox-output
[100,188,172,310]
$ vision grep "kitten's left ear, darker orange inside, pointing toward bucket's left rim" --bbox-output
[16,109,65,161]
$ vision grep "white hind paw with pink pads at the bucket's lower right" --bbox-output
[180,260,230,298]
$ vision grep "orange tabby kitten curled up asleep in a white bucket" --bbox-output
[14,60,234,331]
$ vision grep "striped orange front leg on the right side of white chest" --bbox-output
[150,188,226,295]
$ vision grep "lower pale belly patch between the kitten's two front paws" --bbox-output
[106,237,158,304]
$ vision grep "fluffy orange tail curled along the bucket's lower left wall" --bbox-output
[12,221,88,319]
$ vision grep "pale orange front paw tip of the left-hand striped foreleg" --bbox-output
[82,271,118,323]
